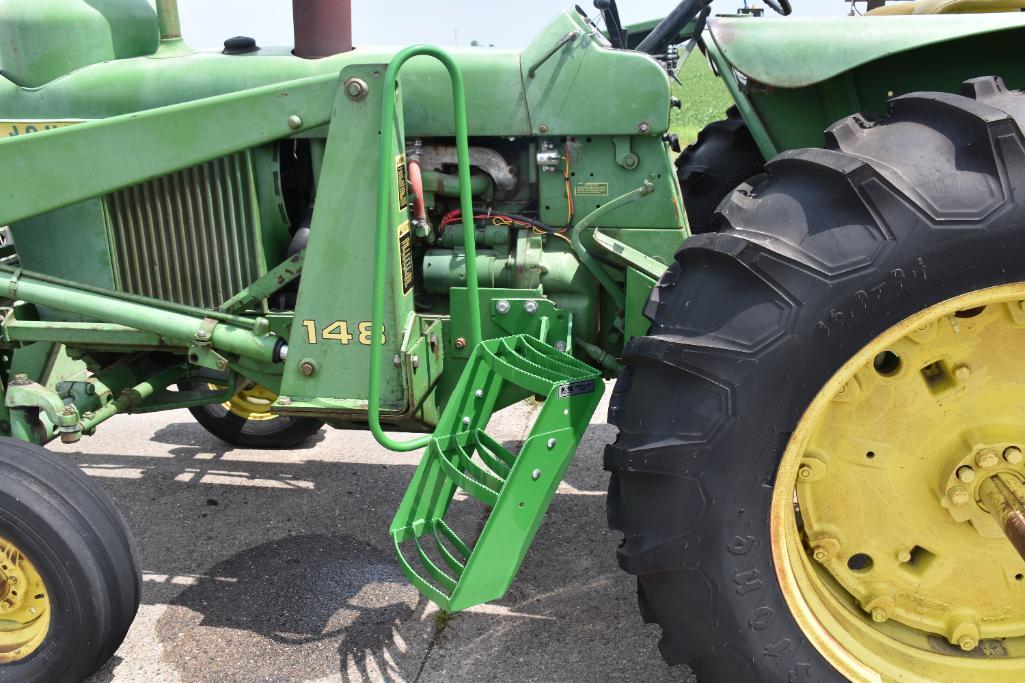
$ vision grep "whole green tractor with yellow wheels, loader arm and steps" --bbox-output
[0,0,1025,683]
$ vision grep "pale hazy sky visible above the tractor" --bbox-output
[178,0,848,48]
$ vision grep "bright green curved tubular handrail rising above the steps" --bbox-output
[367,45,481,451]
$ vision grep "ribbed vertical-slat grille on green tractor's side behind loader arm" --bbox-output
[106,152,263,308]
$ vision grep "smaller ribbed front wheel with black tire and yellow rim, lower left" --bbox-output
[0,438,141,683]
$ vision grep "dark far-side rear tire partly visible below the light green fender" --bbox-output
[677,107,765,235]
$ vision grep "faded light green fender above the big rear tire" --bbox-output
[708,12,1025,88]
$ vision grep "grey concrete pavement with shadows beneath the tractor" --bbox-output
[52,385,685,683]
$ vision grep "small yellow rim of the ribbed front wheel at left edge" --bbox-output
[0,538,50,664]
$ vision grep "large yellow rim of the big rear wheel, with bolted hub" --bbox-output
[771,283,1025,683]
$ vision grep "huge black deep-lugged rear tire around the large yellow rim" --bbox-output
[606,78,1025,683]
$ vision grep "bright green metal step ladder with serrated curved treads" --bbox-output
[392,334,604,611]
